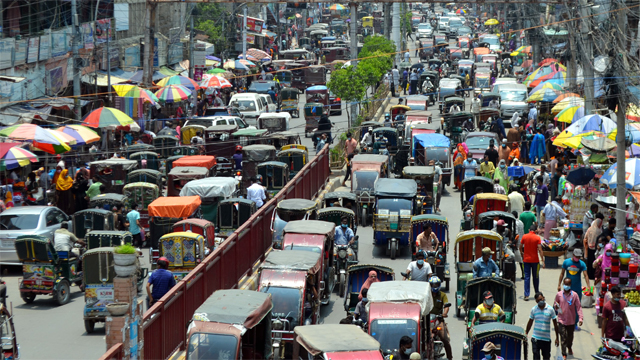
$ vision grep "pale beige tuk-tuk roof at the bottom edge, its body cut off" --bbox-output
[293,324,380,356]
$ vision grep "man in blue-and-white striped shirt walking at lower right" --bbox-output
[525,292,560,360]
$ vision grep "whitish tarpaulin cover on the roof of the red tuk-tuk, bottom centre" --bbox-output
[367,281,433,315]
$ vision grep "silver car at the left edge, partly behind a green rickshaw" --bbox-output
[0,206,70,265]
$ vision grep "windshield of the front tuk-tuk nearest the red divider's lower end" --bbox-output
[187,333,238,360]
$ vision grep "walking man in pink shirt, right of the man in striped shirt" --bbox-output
[553,278,584,359]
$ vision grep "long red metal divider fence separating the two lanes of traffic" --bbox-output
[100,145,331,360]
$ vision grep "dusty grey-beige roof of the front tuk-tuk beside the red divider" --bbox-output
[193,289,273,329]
